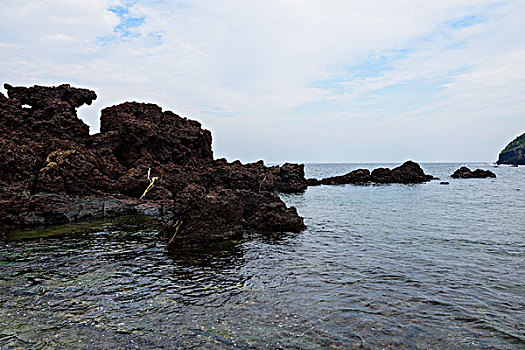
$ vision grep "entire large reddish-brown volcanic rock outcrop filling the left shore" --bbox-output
[0,84,307,245]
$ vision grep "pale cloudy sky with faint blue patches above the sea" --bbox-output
[0,0,525,163]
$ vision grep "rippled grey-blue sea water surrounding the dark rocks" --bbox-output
[0,163,525,349]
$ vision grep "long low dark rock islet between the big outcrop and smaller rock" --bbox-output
[307,160,434,186]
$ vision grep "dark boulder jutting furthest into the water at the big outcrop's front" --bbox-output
[163,184,306,246]
